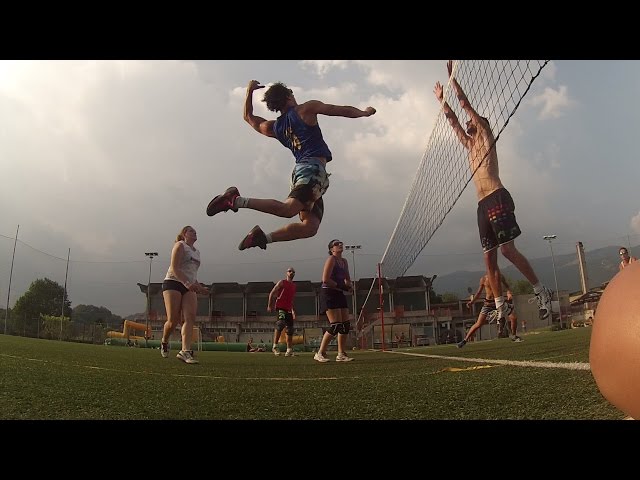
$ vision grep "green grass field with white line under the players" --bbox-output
[0,328,624,420]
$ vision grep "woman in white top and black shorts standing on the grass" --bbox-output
[160,226,209,363]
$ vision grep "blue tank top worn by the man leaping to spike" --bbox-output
[273,108,332,163]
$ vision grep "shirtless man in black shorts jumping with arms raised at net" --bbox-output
[434,60,551,319]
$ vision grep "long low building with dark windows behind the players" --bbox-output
[136,275,547,348]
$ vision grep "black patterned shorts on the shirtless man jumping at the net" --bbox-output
[478,188,522,253]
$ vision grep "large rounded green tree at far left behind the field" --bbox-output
[11,278,71,320]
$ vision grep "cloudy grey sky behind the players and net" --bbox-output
[0,60,640,316]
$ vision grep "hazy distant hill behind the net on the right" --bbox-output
[433,246,638,298]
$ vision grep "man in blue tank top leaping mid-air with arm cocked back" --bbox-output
[207,80,376,250]
